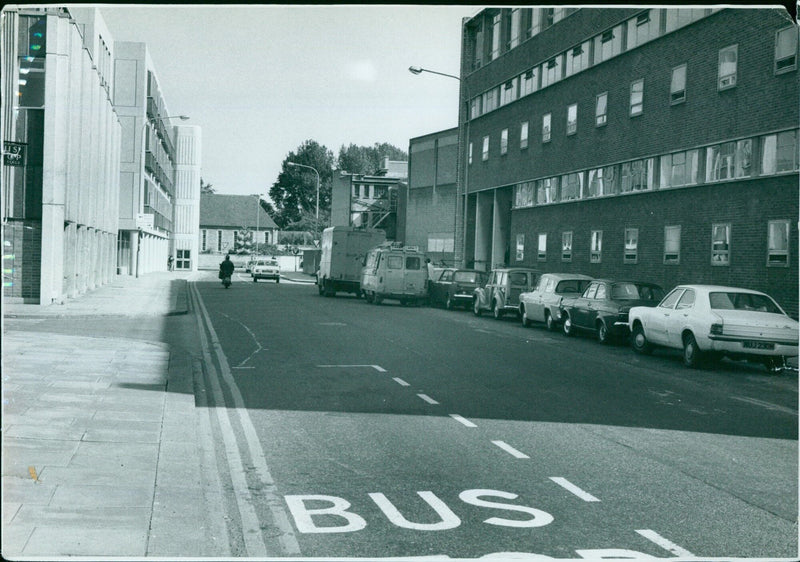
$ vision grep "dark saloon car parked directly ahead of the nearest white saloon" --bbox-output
[561,279,664,343]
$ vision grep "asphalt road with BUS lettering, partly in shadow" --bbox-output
[192,276,798,558]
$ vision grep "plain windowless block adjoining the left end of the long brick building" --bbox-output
[401,128,458,266]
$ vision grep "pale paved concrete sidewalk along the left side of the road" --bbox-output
[2,272,225,560]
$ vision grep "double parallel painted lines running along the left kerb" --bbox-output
[191,283,300,556]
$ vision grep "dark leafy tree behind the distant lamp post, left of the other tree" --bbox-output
[269,140,334,229]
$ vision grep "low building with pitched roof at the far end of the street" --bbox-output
[200,193,278,253]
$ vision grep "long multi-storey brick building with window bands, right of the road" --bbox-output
[456,8,800,316]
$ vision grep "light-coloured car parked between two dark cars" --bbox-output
[519,273,592,330]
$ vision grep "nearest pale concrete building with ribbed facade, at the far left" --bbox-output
[0,6,121,305]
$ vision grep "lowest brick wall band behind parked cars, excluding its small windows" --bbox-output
[510,175,798,317]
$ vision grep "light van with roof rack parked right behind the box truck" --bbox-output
[361,242,428,304]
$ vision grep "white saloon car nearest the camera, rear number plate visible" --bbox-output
[628,285,798,371]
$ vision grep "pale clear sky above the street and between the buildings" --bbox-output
[98,4,480,195]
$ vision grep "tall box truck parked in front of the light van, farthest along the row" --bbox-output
[317,226,386,297]
